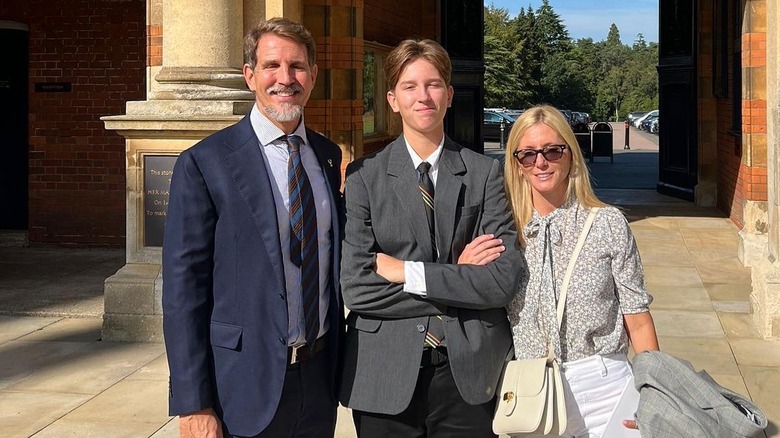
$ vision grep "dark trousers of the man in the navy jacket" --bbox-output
[224,351,338,438]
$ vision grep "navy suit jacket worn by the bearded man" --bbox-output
[162,116,344,436]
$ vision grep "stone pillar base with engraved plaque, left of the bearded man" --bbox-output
[102,108,244,342]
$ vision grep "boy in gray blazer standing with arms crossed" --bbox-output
[339,40,524,438]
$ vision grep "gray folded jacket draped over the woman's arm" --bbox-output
[633,351,767,438]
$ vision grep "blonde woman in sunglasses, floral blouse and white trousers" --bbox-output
[504,105,658,437]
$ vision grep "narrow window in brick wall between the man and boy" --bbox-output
[363,42,390,137]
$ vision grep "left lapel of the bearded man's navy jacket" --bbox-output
[222,115,284,284]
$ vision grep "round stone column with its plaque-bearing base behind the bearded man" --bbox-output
[103,0,302,342]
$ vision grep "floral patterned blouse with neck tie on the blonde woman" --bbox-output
[507,200,653,362]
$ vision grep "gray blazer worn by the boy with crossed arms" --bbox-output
[339,136,526,414]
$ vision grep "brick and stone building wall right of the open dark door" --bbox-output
[684,0,780,338]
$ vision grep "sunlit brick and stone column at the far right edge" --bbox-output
[739,0,780,338]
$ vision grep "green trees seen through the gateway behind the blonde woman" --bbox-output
[485,0,658,120]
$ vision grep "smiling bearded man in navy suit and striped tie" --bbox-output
[163,18,343,438]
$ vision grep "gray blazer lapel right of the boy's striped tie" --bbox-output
[434,137,466,263]
